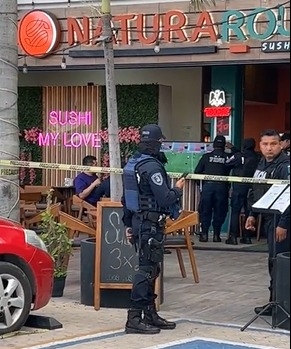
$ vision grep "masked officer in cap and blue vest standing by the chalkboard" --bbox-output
[122,124,185,334]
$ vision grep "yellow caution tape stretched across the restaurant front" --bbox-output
[0,160,290,184]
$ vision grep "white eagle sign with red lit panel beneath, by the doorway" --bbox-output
[204,90,231,118]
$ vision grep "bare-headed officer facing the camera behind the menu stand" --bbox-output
[245,130,290,316]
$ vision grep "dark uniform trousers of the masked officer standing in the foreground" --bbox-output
[131,217,164,310]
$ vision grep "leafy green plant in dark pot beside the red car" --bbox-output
[40,189,72,297]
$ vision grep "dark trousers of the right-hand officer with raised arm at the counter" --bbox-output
[229,184,250,237]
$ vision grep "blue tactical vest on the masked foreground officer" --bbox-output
[123,154,158,212]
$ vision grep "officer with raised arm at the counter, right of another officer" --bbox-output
[225,138,259,245]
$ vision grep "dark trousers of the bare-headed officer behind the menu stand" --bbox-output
[263,215,290,301]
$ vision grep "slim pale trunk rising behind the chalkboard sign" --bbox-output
[101,0,122,201]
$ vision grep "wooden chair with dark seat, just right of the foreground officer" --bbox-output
[165,211,199,283]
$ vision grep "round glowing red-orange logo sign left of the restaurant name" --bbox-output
[18,10,61,58]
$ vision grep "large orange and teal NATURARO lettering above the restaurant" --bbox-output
[67,6,290,45]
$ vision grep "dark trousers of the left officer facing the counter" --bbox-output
[199,182,229,234]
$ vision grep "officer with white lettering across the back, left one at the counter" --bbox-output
[194,135,234,242]
